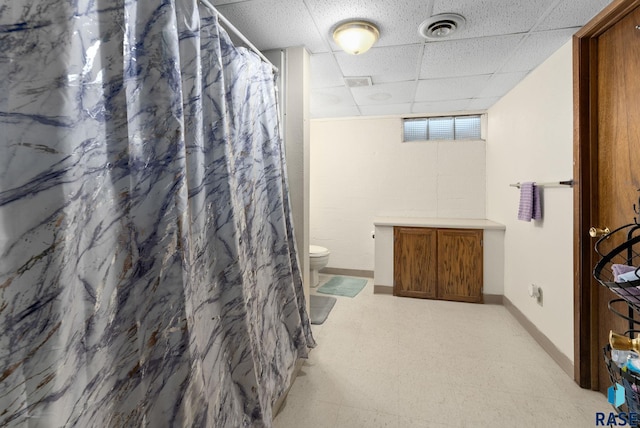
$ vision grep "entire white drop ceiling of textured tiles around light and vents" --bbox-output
[212,0,610,118]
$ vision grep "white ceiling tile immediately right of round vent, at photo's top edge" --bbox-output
[433,0,556,38]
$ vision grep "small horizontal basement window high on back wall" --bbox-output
[402,115,482,142]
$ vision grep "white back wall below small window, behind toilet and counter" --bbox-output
[310,117,485,270]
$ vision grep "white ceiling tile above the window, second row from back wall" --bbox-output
[415,74,491,102]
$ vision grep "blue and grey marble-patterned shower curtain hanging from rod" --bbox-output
[0,0,314,427]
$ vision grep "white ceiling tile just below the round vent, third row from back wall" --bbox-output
[420,35,524,79]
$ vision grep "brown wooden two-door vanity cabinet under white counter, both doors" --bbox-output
[393,227,483,303]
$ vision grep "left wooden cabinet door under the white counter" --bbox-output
[393,227,438,299]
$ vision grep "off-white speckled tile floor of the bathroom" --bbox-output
[274,275,611,428]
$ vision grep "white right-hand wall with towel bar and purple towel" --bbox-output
[486,42,573,361]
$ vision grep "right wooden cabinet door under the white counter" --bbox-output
[438,229,483,303]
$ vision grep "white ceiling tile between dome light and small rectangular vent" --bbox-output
[335,45,422,84]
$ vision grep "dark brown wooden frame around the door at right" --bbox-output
[573,0,640,390]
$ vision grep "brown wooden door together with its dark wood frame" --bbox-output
[574,0,640,392]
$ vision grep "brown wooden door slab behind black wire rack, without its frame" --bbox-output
[591,9,640,392]
